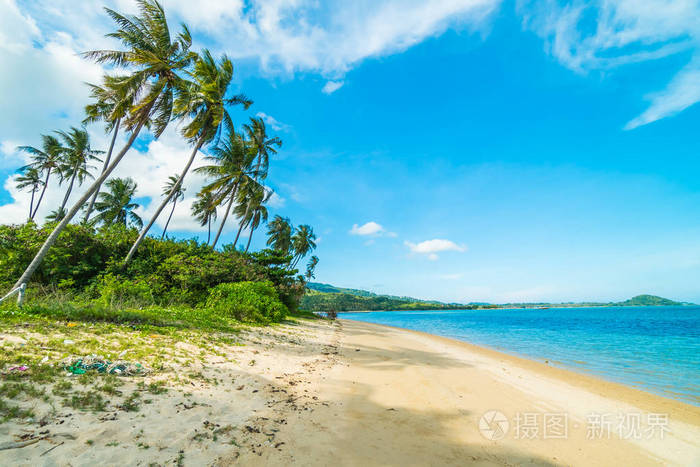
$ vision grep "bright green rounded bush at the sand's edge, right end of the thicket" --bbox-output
[206,281,289,324]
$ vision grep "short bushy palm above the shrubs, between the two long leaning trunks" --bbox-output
[95,178,143,228]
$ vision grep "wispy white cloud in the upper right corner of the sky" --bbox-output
[519,0,700,129]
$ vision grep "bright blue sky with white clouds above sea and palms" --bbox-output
[0,0,700,302]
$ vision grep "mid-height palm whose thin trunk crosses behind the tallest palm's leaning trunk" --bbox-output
[83,75,134,222]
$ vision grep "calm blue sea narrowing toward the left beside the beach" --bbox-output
[340,306,700,405]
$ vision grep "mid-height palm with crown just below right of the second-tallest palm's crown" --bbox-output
[196,131,256,248]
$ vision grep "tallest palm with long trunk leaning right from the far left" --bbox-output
[10,0,195,287]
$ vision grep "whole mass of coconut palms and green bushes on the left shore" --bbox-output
[0,0,318,323]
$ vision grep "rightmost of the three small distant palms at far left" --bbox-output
[56,127,102,215]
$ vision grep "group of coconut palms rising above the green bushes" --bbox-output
[6,0,318,296]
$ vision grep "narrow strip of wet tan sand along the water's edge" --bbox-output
[341,318,700,426]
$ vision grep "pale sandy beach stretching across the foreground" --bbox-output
[0,320,700,466]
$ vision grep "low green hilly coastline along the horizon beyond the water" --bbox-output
[300,282,693,311]
